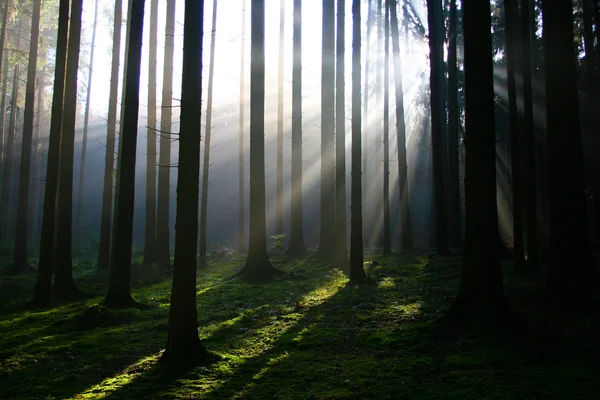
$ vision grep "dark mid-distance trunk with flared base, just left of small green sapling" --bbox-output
[238,0,281,279]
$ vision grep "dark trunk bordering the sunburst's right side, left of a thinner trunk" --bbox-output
[427,0,448,255]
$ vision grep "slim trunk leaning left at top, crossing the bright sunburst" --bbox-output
[389,0,413,250]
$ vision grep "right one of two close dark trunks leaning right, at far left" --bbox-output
[54,0,83,300]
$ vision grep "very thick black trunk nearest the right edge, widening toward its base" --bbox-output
[542,0,598,306]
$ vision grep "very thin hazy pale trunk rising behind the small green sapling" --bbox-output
[275,0,285,234]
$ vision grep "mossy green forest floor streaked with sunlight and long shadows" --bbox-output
[0,248,600,400]
